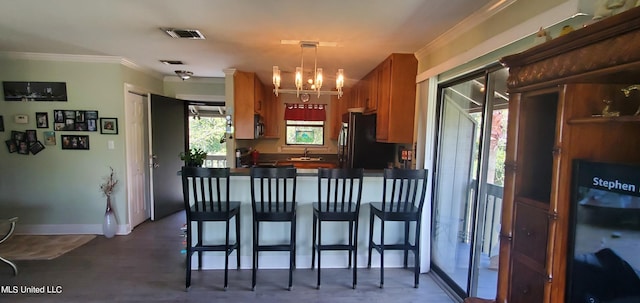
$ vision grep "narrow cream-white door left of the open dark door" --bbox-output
[125,90,151,229]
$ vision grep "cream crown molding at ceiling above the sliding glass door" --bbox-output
[415,0,518,58]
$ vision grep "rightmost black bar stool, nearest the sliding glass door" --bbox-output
[367,169,427,288]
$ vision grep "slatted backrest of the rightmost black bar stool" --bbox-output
[382,168,427,213]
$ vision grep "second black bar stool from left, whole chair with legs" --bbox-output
[250,167,297,290]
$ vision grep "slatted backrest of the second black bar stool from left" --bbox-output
[250,167,297,213]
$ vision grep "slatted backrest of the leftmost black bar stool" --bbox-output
[182,167,230,220]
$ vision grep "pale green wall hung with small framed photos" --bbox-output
[0,58,162,233]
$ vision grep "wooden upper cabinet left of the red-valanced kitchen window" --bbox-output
[233,71,264,139]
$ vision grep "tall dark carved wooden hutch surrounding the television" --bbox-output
[496,8,640,303]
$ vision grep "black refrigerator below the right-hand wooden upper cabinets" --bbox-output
[338,112,395,169]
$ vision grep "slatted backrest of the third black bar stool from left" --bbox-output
[318,168,364,212]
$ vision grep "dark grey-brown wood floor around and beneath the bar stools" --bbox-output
[0,212,454,303]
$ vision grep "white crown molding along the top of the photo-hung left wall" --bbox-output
[0,52,163,80]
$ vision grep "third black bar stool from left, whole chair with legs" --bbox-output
[311,168,363,289]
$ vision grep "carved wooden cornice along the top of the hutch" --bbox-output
[500,7,640,89]
